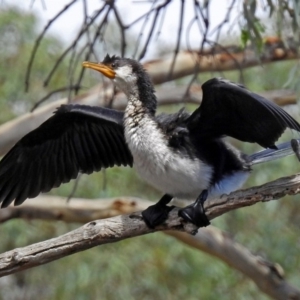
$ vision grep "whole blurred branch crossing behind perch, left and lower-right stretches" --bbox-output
[0,195,300,299]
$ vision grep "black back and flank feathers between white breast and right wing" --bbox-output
[155,109,250,183]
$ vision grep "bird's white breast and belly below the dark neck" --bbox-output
[125,107,212,199]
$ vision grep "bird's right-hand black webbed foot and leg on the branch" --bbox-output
[178,190,210,227]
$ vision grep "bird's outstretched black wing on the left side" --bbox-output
[0,105,133,207]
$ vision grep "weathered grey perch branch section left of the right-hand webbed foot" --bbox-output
[0,209,196,277]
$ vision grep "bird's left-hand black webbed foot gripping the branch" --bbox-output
[142,194,174,228]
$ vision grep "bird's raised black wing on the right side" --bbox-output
[188,78,300,148]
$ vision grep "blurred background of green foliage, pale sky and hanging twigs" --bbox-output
[0,0,300,300]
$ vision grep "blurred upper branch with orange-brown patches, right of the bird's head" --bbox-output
[144,37,299,84]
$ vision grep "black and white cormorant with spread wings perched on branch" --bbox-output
[0,55,300,227]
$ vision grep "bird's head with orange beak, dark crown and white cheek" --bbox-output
[82,54,145,94]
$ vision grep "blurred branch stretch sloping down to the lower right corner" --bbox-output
[168,230,300,300]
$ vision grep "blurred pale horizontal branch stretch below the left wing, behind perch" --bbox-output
[0,195,153,223]
